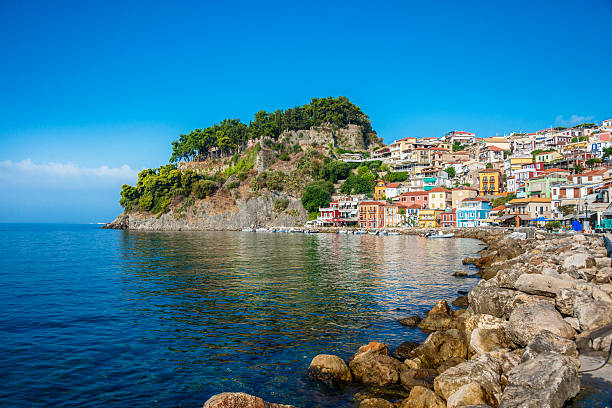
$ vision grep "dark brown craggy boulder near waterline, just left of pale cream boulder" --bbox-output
[412,329,467,368]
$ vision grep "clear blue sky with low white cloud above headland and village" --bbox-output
[0,0,612,223]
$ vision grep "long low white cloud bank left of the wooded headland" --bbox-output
[0,159,138,187]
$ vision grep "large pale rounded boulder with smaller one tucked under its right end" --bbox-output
[506,302,576,347]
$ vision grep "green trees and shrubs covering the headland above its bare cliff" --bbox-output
[120,97,387,220]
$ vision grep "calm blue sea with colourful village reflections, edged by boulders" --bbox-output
[0,224,482,408]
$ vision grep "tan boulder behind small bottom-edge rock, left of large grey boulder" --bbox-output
[434,354,502,405]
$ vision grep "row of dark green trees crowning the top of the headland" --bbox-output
[170,96,376,162]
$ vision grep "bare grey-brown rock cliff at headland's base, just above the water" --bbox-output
[105,192,308,231]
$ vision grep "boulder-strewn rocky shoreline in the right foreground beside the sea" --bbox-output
[204,229,612,408]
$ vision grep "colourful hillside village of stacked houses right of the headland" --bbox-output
[318,119,612,231]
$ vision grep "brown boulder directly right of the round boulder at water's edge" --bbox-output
[349,352,406,387]
